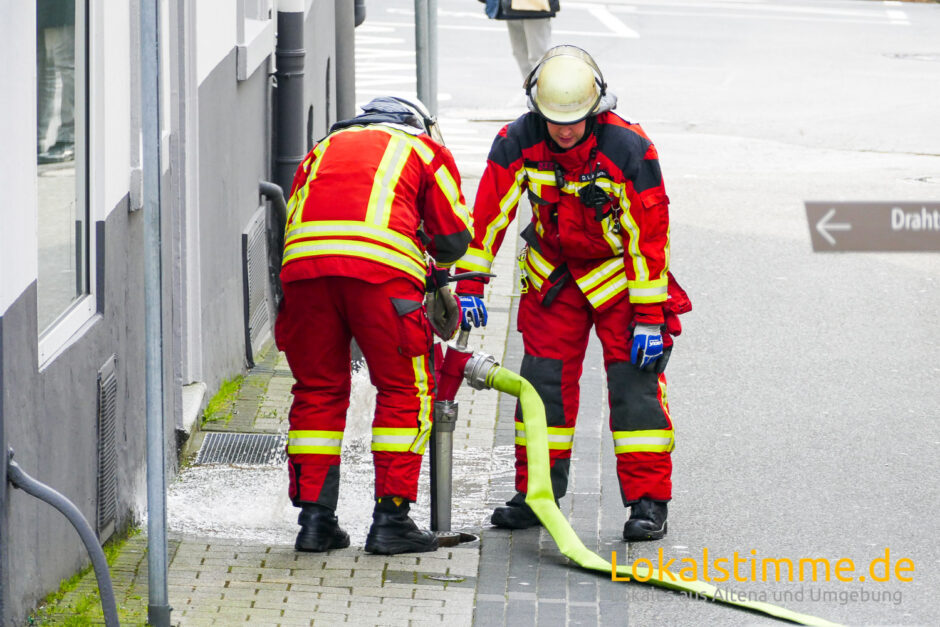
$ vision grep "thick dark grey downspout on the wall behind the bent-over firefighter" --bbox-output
[274,2,307,196]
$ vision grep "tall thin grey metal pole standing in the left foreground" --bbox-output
[140,0,172,627]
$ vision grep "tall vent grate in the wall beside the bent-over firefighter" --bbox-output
[242,206,271,367]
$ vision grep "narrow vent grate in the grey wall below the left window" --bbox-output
[97,355,117,542]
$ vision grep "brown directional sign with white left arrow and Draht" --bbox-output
[806,202,940,253]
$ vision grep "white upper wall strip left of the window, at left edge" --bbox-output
[0,1,39,316]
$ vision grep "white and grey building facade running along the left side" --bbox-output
[0,0,335,625]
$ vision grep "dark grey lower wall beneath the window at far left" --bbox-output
[0,198,149,624]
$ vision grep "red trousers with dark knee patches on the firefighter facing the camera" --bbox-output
[515,279,674,505]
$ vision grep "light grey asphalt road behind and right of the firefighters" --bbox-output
[357,0,940,625]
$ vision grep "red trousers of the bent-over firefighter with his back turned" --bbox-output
[275,276,434,509]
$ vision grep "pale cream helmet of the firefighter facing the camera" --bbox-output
[523,45,607,124]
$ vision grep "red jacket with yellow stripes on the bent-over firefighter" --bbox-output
[281,124,473,290]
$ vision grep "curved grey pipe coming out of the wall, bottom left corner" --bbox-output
[7,449,120,627]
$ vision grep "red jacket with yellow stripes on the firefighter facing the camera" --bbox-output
[457,111,685,324]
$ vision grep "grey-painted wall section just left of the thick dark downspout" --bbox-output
[199,49,268,392]
